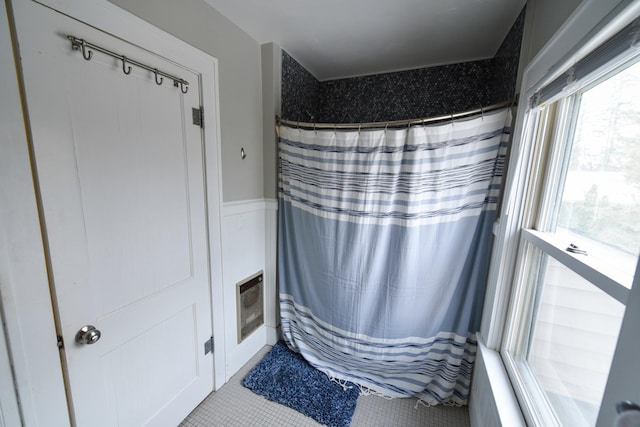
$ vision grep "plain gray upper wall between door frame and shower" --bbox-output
[110,0,264,202]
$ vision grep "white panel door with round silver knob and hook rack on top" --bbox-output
[17,4,213,426]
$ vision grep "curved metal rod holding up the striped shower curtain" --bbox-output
[276,96,518,129]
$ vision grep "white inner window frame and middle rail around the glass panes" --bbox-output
[500,62,640,426]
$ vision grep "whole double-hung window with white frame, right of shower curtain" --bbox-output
[502,49,640,426]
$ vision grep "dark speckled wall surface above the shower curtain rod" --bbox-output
[282,9,525,123]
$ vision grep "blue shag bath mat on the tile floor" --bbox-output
[243,341,360,427]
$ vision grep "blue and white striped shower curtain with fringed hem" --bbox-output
[278,110,511,405]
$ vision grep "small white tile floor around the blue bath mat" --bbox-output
[180,347,469,427]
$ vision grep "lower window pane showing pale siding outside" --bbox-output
[527,255,624,426]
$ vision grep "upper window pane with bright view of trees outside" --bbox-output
[557,63,640,280]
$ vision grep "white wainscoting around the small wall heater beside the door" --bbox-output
[221,199,278,382]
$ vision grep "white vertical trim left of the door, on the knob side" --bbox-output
[0,4,69,426]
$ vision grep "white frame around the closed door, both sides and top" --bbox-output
[0,0,226,426]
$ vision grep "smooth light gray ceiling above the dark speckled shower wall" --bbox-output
[205,0,525,80]
